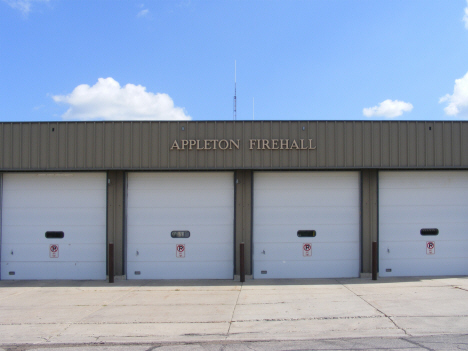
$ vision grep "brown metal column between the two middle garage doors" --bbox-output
[235,170,252,274]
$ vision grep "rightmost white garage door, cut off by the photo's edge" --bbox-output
[379,171,468,277]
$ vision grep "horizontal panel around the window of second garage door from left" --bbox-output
[127,225,232,244]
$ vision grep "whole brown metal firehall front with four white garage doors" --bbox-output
[0,121,468,280]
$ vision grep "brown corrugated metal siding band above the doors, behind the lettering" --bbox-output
[0,121,468,171]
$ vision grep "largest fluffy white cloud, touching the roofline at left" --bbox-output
[52,78,191,120]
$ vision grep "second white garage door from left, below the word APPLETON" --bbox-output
[127,172,234,279]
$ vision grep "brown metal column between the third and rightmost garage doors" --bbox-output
[361,169,379,273]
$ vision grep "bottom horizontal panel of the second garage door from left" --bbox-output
[127,262,233,279]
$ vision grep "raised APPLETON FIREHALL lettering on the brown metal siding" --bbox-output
[171,139,317,150]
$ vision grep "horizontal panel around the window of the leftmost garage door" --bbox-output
[2,225,106,244]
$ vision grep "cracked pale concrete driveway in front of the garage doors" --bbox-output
[0,277,468,346]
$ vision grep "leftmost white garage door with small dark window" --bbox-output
[1,173,106,280]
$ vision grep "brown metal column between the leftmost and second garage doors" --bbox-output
[107,171,125,276]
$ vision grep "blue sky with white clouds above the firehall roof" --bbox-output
[0,0,468,121]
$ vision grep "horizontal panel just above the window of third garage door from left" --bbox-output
[255,206,359,225]
